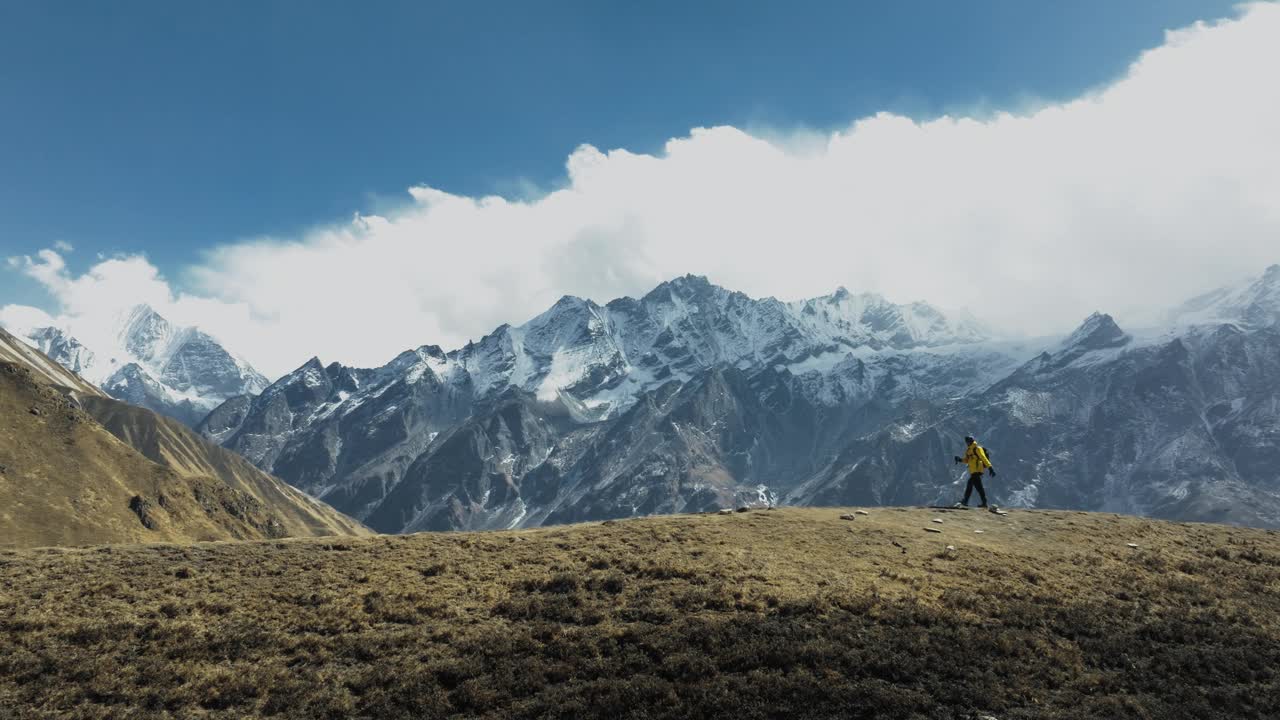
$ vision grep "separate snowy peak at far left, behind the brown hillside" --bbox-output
[13,305,269,425]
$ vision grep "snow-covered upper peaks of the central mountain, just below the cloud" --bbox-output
[448,275,988,416]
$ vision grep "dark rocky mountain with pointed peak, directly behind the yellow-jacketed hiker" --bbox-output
[787,315,1280,527]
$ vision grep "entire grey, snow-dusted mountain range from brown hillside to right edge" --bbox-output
[200,270,1280,532]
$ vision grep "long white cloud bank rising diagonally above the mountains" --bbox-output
[2,4,1280,374]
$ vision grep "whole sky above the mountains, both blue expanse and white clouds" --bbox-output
[0,0,1280,375]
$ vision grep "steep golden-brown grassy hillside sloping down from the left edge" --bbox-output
[0,331,369,547]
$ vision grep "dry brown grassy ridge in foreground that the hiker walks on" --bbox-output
[0,509,1280,720]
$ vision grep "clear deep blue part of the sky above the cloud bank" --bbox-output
[0,0,1231,302]
